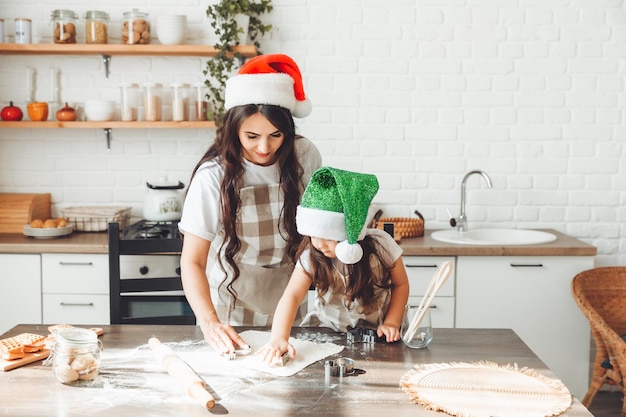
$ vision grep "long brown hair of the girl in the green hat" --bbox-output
[297,235,393,313]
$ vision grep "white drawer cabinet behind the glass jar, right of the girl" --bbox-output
[402,256,456,328]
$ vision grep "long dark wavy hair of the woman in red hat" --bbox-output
[185,104,305,300]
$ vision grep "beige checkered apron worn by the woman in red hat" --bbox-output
[209,184,306,326]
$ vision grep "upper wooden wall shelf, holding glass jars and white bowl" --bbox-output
[0,43,258,58]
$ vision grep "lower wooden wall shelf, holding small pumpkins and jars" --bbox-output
[0,120,215,129]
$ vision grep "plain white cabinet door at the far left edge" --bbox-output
[0,254,42,332]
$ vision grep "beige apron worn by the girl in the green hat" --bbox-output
[301,258,391,332]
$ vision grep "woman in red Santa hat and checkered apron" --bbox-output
[179,54,321,353]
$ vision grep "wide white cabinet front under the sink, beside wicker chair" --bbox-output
[456,256,594,397]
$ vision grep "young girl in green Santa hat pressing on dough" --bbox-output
[259,167,409,363]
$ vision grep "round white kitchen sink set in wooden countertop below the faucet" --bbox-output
[430,228,556,246]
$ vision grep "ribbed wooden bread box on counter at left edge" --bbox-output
[0,193,51,233]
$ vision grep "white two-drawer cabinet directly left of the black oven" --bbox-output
[41,253,110,325]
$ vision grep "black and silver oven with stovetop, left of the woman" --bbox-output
[108,220,196,324]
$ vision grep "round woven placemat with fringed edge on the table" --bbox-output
[400,361,572,417]
